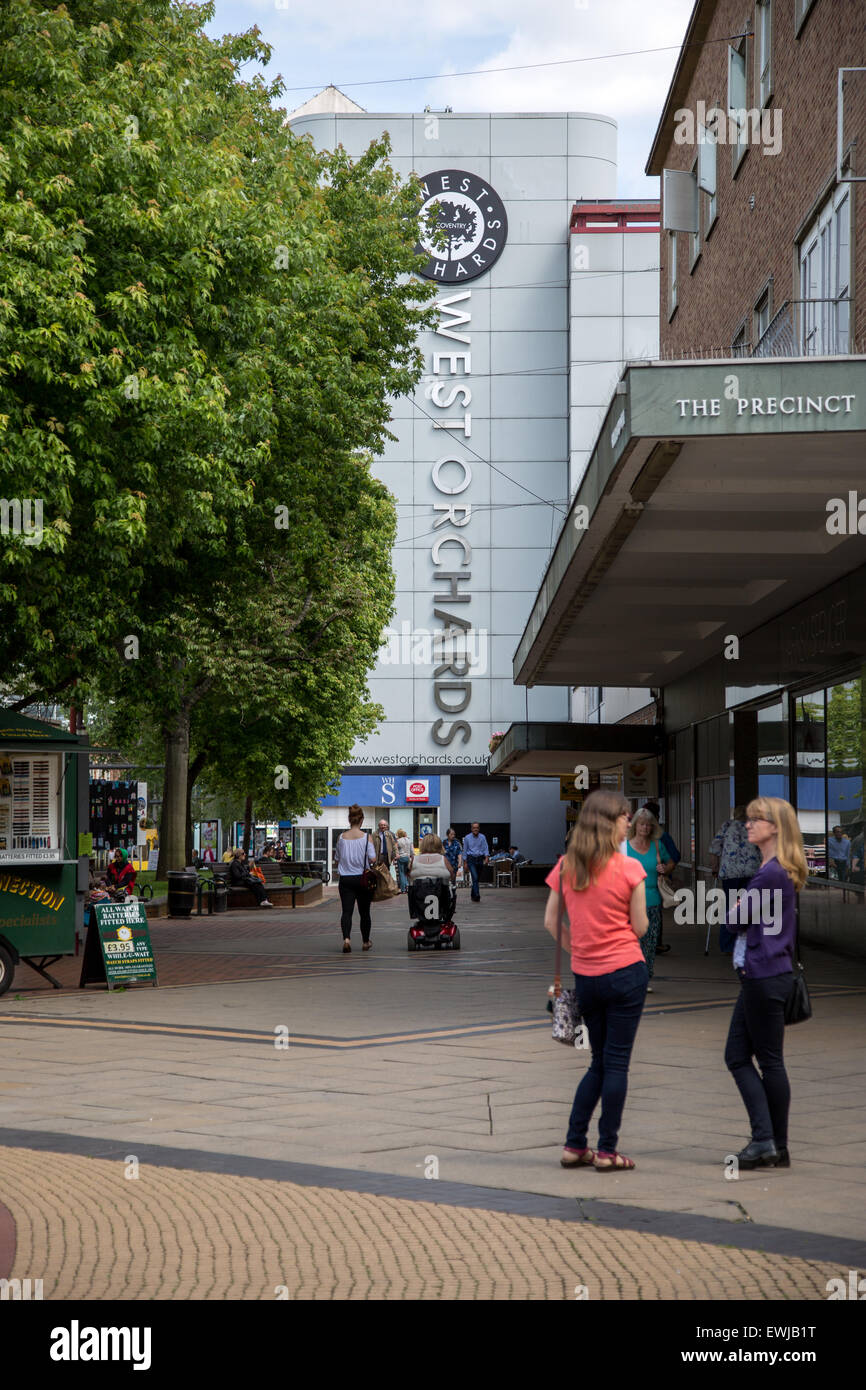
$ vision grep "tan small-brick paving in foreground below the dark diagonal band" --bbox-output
[0,1148,840,1300]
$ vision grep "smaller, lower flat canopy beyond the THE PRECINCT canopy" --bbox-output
[489,723,662,777]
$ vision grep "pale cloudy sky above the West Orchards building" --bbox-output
[207,0,692,197]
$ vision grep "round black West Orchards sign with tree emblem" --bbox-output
[417,170,509,285]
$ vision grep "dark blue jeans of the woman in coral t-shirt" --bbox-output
[566,960,649,1154]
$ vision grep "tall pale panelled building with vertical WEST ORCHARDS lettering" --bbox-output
[291,105,657,860]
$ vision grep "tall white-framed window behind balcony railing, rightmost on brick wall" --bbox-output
[796,185,851,356]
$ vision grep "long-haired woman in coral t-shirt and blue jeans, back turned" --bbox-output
[545,791,649,1172]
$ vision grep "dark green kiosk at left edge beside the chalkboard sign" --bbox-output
[0,709,89,994]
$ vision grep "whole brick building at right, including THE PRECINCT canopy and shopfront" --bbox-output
[491,0,866,955]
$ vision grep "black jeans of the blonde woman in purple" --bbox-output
[724,970,794,1148]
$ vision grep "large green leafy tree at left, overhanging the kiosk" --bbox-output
[0,0,435,869]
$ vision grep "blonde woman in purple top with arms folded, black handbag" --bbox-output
[724,796,808,1168]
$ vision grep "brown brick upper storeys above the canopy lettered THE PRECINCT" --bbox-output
[646,0,866,357]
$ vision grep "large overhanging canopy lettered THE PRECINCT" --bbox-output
[514,357,866,687]
